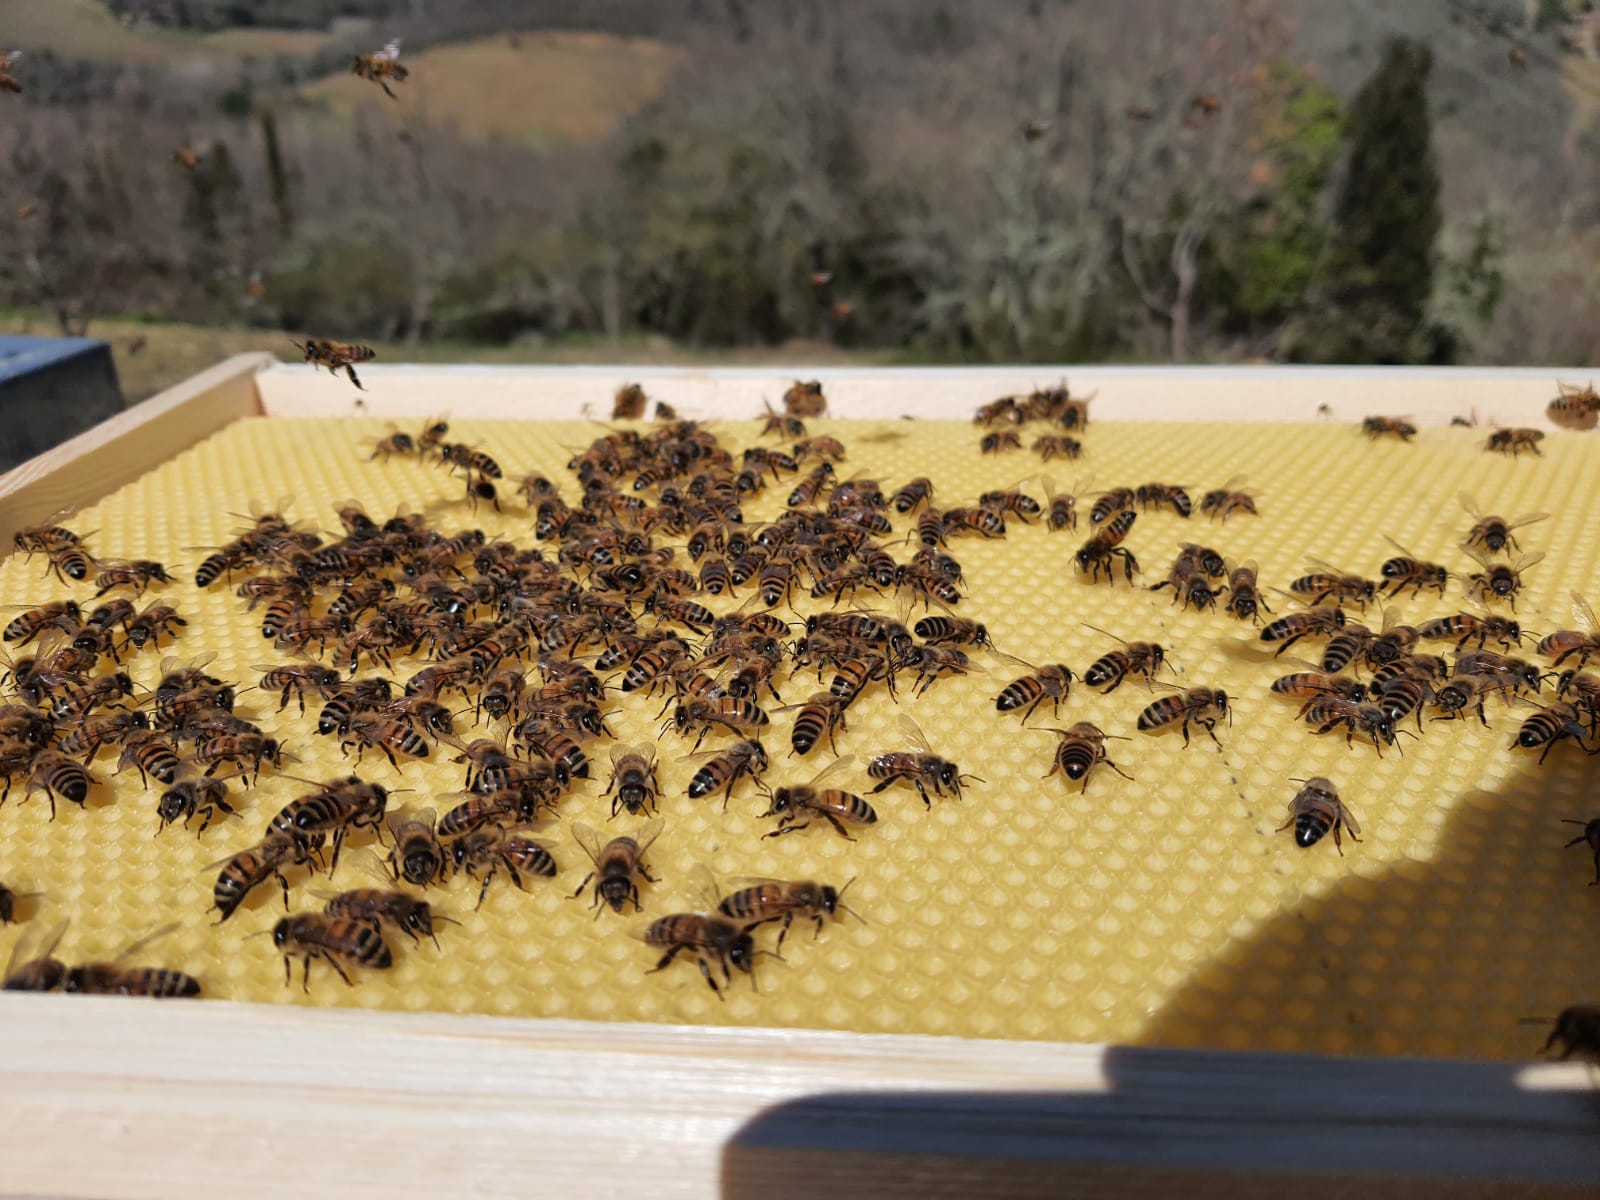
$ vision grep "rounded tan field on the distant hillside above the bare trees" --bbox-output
[299,32,682,144]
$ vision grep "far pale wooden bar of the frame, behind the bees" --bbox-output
[259,363,1576,435]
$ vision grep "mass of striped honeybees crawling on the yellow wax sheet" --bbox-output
[0,377,1600,1050]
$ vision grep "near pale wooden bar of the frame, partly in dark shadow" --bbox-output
[0,995,1600,1200]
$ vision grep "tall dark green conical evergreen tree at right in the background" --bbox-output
[1294,38,1453,363]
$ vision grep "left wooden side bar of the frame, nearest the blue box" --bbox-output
[0,354,277,555]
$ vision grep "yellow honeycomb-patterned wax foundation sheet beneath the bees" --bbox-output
[0,404,1600,1056]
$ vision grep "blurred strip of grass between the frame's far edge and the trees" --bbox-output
[0,312,891,403]
